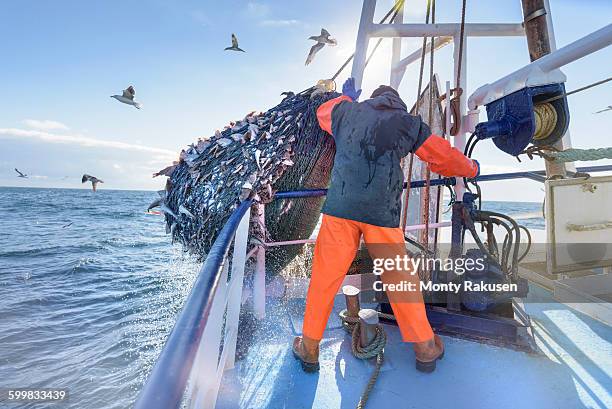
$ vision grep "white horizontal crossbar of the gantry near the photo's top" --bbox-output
[369,23,525,38]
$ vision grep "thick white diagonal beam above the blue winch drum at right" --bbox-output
[468,24,612,109]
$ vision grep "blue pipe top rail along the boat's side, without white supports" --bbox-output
[135,161,612,409]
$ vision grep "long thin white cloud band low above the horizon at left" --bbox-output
[0,128,177,160]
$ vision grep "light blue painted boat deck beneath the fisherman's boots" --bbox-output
[217,285,612,409]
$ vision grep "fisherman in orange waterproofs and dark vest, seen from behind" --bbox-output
[293,78,480,372]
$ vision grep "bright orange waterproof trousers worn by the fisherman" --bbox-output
[302,214,433,342]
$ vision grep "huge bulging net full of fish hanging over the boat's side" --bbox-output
[152,89,339,271]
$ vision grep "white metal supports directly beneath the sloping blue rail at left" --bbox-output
[187,212,250,409]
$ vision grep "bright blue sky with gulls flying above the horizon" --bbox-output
[0,0,612,201]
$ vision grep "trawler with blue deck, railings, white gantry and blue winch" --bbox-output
[135,0,612,409]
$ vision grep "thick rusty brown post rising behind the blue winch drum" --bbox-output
[521,0,567,177]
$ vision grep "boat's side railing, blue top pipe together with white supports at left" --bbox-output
[135,165,612,409]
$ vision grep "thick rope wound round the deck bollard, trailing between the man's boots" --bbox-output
[340,310,393,409]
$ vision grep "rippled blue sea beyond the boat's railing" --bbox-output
[0,187,544,409]
